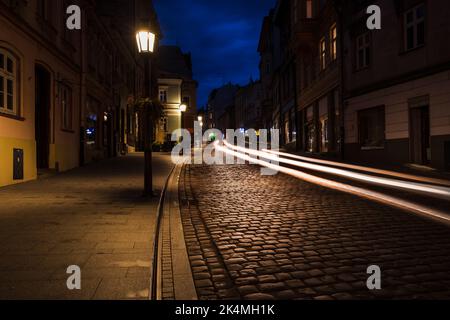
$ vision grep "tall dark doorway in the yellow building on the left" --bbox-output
[35,66,51,169]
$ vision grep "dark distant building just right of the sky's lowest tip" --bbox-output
[205,83,239,134]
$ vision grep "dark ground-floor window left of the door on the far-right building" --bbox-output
[358,106,386,150]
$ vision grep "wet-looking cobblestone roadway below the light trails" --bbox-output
[180,165,450,300]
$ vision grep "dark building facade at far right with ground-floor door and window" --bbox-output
[344,0,450,170]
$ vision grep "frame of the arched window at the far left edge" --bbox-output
[0,47,20,116]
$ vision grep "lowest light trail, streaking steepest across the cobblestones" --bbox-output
[214,141,450,223]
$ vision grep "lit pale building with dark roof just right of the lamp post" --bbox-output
[155,46,198,143]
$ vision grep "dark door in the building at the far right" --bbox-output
[410,106,431,165]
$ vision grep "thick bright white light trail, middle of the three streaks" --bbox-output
[223,141,450,200]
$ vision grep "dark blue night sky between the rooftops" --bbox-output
[154,0,275,107]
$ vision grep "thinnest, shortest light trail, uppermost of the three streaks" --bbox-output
[262,149,450,187]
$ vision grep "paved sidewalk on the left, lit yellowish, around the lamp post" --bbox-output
[0,154,173,299]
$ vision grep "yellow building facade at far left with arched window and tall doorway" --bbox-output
[0,2,80,187]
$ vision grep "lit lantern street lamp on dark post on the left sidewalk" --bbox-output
[136,29,156,197]
